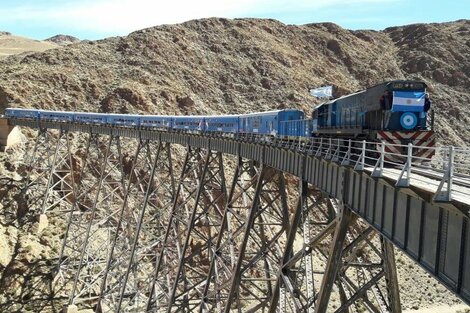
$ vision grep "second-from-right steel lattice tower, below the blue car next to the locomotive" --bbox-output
[222,167,290,312]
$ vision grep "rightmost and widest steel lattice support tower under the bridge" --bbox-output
[314,202,401,313]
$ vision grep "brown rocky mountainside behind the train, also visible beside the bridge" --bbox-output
[0,18,470,309]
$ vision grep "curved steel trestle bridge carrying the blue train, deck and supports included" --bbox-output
[3,118,470,313]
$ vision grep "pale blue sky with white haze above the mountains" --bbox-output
[0,0,470,39]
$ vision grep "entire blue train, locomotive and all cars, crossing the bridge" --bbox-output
[5,80,435,157]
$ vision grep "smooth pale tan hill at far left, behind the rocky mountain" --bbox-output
[0,31,59,60]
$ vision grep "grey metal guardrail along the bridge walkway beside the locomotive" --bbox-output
[232,133,470,201]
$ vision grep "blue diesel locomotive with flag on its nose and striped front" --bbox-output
[312,80,435,161]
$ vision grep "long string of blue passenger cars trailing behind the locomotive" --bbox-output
[5,108,304,136]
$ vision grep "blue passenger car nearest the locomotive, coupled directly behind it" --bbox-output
[239,109,304,136]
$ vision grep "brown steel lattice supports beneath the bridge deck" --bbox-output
[23,130,400,313]
